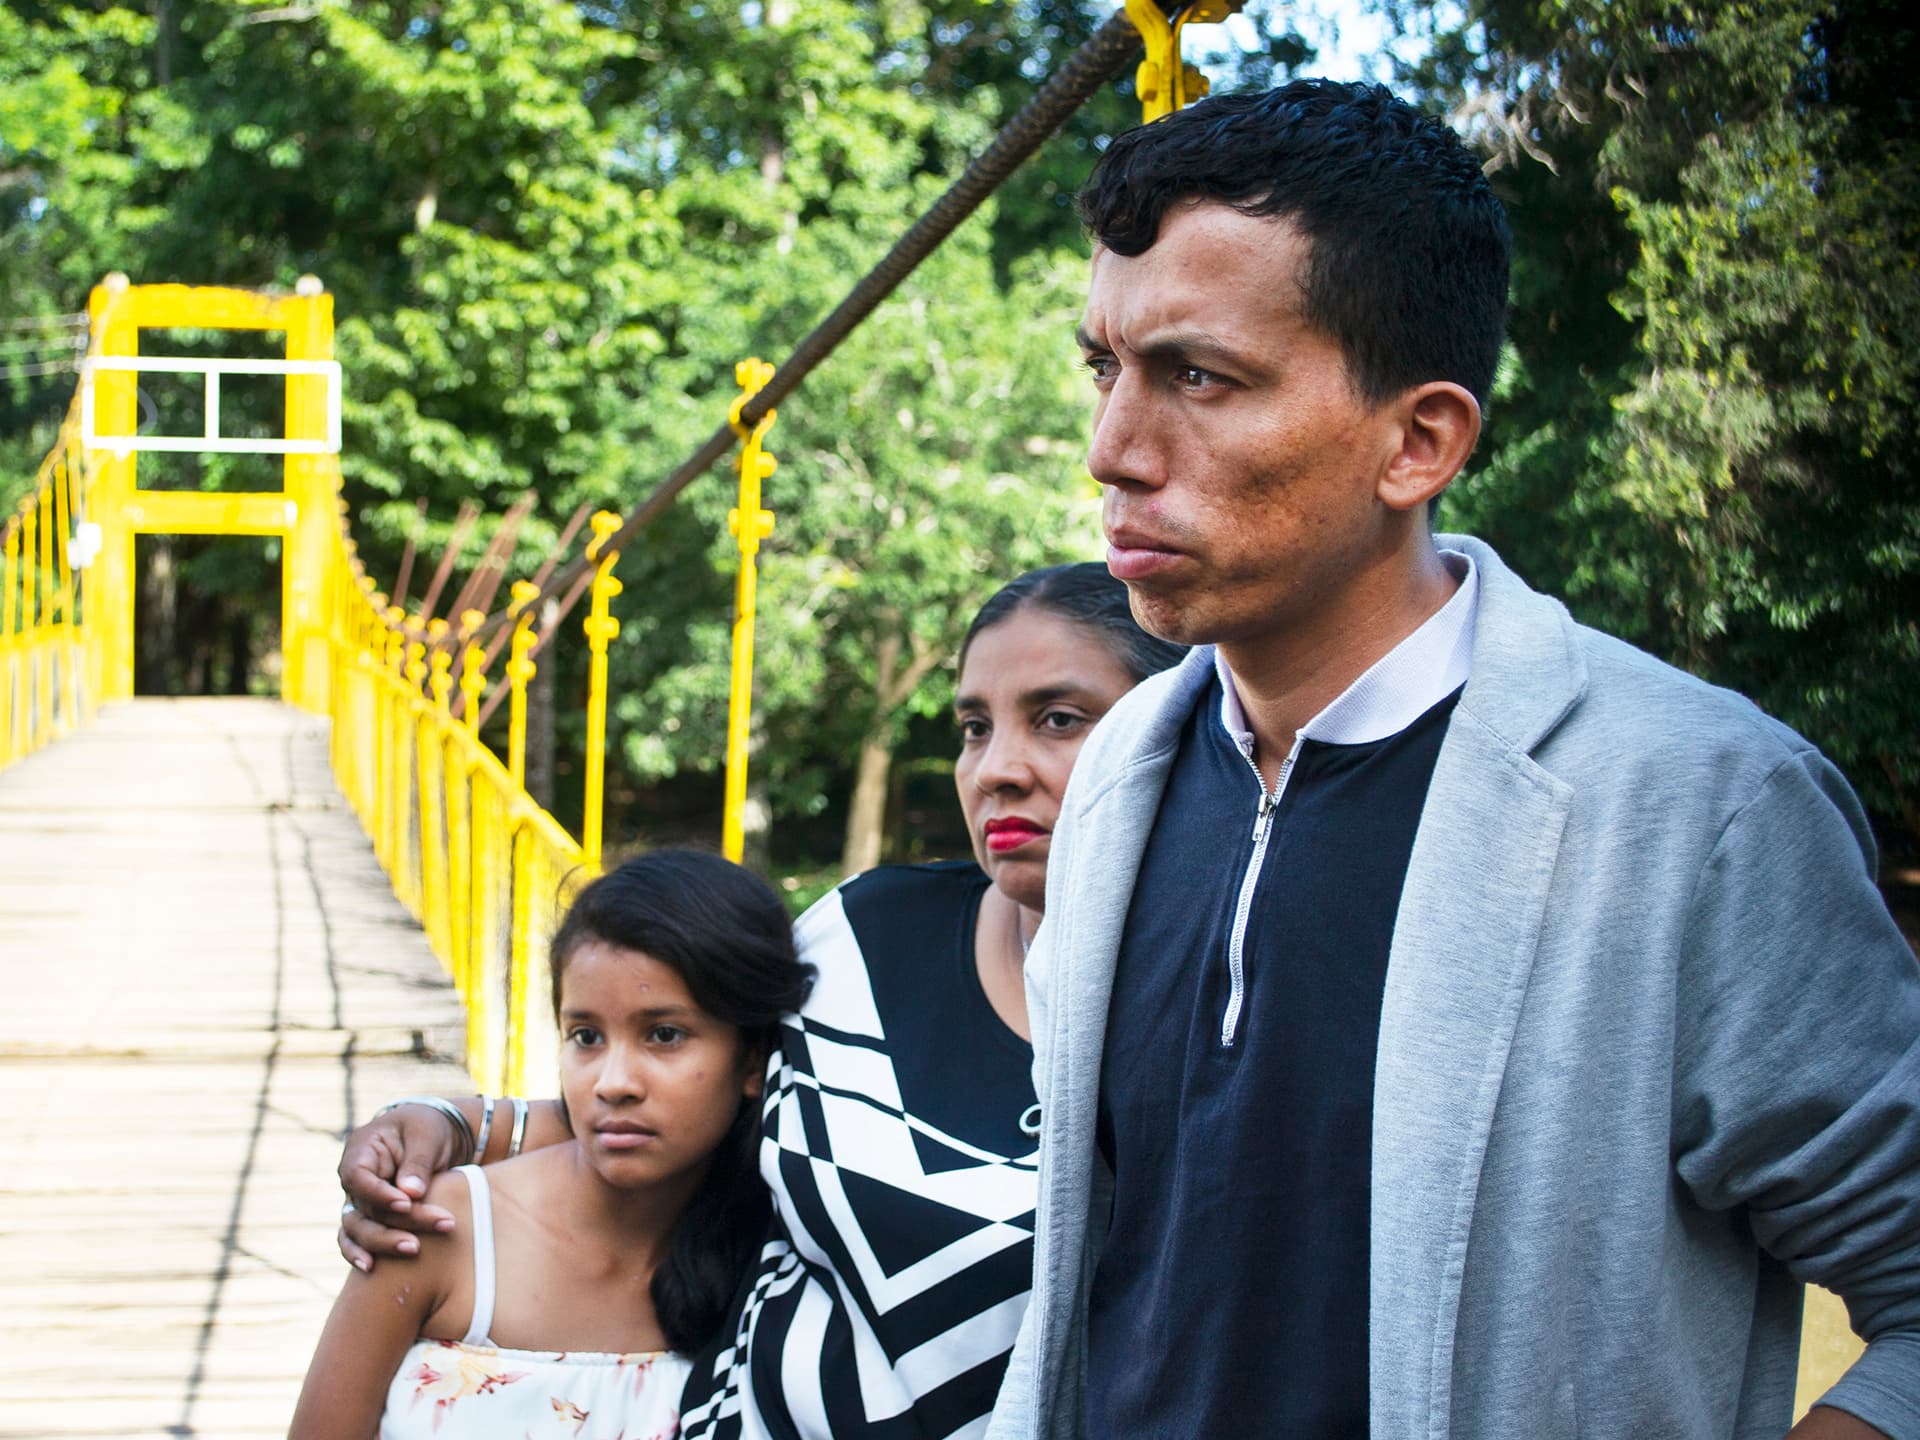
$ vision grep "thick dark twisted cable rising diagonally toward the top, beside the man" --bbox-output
[460,0,1167,648]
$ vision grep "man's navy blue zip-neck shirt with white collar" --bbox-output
[1087,553,1478,1440]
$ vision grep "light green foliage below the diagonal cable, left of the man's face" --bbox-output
[620,232,1098,870]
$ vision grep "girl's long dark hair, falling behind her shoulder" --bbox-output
[553,851,814,1354]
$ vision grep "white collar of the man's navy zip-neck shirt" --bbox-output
[1213,549,1480,758]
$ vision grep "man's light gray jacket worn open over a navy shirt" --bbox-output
[989,536,1920,1440]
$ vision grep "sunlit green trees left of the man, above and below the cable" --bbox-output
[0,0,1271,867]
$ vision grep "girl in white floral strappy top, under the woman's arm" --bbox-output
[290,851,810,1440]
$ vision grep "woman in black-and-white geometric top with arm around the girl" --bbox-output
[340,564,1181,1440]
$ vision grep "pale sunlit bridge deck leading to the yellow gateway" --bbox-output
[0,699,472,1440]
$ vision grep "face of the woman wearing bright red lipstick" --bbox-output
[954,605,1133,910]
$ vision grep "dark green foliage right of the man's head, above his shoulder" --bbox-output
[1415,0,1920,835]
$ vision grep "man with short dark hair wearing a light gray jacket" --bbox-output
[991,81,1920,1440]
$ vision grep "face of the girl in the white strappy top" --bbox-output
[561,939,766,1188]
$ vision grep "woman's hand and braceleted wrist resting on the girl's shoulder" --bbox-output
[338,1098,572,1271]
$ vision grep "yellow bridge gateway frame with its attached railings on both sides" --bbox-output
[0,276,652,1094]
